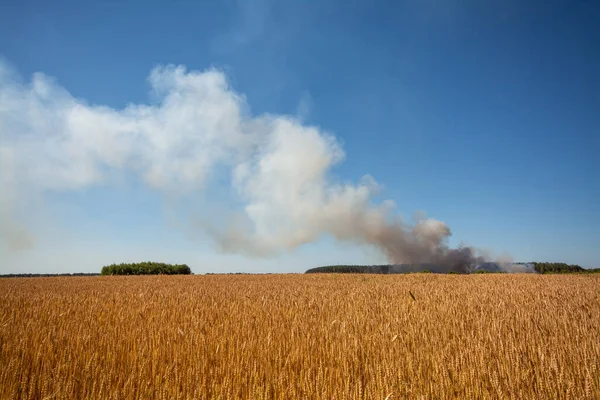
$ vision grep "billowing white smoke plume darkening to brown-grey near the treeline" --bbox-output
[0,63,502,270]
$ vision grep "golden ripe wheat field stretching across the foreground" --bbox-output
[0,274,600,399]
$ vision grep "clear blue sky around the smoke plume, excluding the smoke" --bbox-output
[0,0,600,273]
